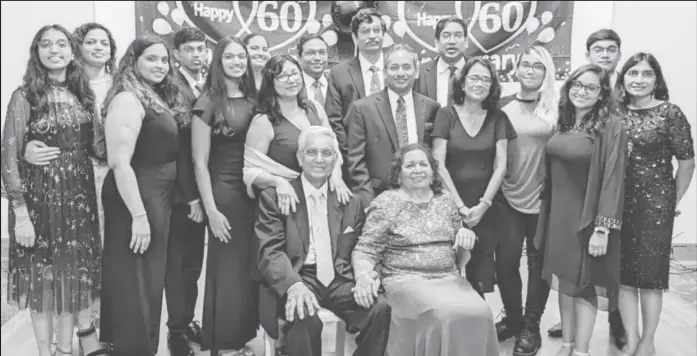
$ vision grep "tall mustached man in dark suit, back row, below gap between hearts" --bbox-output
[325,8,387,156]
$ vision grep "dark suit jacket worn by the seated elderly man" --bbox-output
[254,178,364,339]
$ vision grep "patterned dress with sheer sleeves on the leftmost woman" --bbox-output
[2,82,101,314]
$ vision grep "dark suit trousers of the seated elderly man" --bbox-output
[278,266,391,356]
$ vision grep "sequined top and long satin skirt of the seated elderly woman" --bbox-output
[353,190,499,356]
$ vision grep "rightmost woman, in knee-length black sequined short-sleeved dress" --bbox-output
[616,53,695,356]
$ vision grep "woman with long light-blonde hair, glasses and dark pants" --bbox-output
[496,46,559,355]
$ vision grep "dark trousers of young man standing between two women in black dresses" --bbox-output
[165,203,206,332]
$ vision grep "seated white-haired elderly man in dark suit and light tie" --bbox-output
[255,126,391,356]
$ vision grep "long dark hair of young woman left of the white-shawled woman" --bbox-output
[203,36,257,128]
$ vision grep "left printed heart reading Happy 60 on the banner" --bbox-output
[177,1,324,52]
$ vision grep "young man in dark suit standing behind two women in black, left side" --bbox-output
[165,27,206,356]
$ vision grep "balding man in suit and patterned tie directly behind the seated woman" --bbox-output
[346,45,440,204]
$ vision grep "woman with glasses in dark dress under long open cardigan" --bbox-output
[534,64,627,356]
